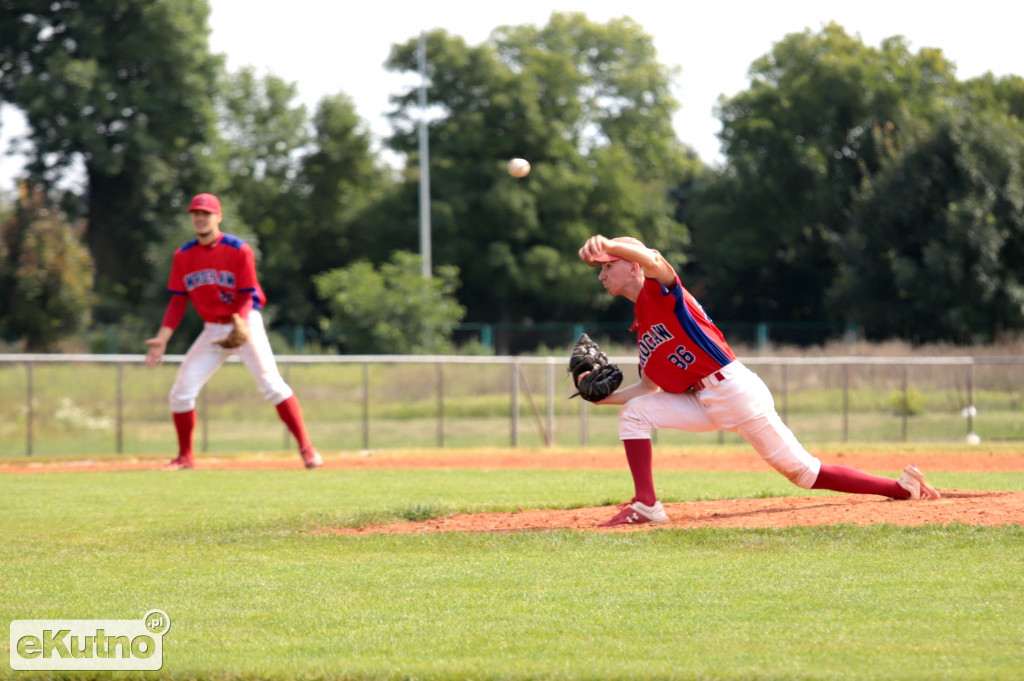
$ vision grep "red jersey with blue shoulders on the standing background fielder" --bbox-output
[167,233,266,322]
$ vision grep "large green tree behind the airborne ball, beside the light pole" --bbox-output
[386,13,694,351]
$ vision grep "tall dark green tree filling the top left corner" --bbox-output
[0,0,222,314]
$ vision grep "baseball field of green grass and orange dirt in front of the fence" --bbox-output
[0,444,1024,680]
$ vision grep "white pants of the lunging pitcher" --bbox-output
[618,361,821,490]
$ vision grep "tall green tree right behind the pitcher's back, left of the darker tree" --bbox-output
[686,24,956,322]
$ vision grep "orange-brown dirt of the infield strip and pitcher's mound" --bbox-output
[9,448,1024,535]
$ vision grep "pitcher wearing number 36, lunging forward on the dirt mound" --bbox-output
[575,235,939,526]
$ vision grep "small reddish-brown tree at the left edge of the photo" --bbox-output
[0,185,92,352]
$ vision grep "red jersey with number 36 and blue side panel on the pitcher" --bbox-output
[631,276,736,392]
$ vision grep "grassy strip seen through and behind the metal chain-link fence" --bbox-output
[0,356,1024,457]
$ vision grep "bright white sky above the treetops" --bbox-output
[0,0,1024,190]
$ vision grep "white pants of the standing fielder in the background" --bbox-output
[169,310,292,413]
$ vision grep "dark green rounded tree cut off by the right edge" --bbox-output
[828,108,1024,343]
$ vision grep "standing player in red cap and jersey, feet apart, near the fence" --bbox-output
[145,194,323,470]
